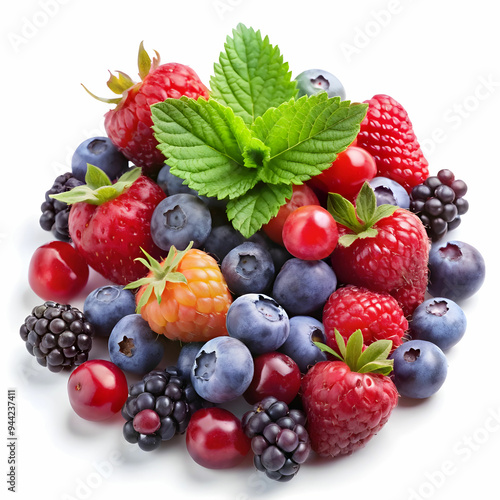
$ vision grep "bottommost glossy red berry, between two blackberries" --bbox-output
[186,407,250,469]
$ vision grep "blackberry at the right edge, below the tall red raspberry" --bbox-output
[410,169,469,241]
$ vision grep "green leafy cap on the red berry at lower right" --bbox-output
[314,329,394,375]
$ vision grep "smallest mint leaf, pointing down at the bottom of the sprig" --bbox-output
[227,183,293,238]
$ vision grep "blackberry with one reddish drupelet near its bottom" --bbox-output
[122,367,206,451]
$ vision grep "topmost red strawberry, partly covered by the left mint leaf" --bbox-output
[84,43,208,177]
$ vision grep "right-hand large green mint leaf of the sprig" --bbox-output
[252,92,367,184]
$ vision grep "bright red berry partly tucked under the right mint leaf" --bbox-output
[309,146,377,201]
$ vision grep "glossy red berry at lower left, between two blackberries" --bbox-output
[68,359,128,421]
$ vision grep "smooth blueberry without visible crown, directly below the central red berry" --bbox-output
[272,258,337,316]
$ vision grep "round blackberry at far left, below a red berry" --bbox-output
[19,301,94,372]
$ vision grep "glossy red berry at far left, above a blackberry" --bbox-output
[28,241,89,304]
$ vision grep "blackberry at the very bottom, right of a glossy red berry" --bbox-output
[242,396,311,482]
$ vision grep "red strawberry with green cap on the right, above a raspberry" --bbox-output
[328,183,430,316]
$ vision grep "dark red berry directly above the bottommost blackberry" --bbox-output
[243,352,300,405]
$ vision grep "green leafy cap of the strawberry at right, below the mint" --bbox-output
[327,182,399,247]
